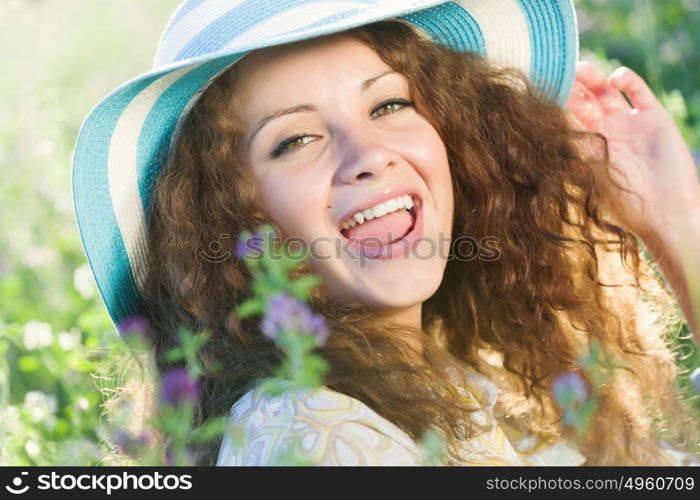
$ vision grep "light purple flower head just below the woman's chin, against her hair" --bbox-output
[261,293,328,346]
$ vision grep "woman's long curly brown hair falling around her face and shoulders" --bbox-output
[144,20,698,465]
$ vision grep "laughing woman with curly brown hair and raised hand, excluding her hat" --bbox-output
[76,2,700,465]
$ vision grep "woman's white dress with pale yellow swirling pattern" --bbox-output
[217,367,697,466]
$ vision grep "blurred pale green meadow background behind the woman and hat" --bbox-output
[0,0,700,465]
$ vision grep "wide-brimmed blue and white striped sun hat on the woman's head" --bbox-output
[73,0,578,324]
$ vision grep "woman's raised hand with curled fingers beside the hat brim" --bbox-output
[568,62,700,238]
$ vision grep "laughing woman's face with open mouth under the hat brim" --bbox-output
[237,34,453,310]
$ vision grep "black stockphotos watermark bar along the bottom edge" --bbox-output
[0,467,700,500]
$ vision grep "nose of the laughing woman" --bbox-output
[336,127,399,184]
